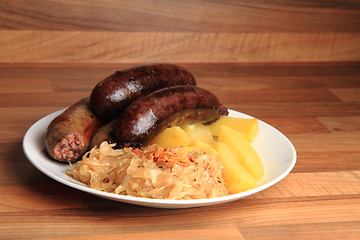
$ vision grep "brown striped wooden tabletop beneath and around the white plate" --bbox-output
[0,63,360,240]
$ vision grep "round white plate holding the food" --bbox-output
[23,110,296,208]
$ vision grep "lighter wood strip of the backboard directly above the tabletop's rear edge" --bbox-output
[0,30,360,63]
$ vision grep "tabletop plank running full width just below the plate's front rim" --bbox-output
[0,198,360,239]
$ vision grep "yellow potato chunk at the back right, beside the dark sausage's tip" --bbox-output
[210,115,259,141]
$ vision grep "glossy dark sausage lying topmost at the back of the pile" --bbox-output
[90,63,196,119]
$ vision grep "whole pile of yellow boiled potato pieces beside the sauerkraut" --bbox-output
[150,119,265,193]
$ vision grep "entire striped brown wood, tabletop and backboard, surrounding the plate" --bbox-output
[0,0,360,237]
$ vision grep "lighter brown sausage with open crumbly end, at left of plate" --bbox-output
[45,98,103,162]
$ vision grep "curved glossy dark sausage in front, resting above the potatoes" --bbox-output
[114,86,227,148]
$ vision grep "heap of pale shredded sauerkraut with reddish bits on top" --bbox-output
[66,142,228,199]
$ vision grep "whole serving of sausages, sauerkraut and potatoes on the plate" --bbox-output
[46,64,265,199]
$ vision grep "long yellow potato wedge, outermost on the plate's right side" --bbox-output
[218,125,265,180]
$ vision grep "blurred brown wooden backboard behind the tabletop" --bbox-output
[0,0,360,63]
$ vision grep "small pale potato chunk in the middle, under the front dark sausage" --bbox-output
[180,123,214,144]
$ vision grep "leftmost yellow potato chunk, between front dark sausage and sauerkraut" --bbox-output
[148,126,191,148]
